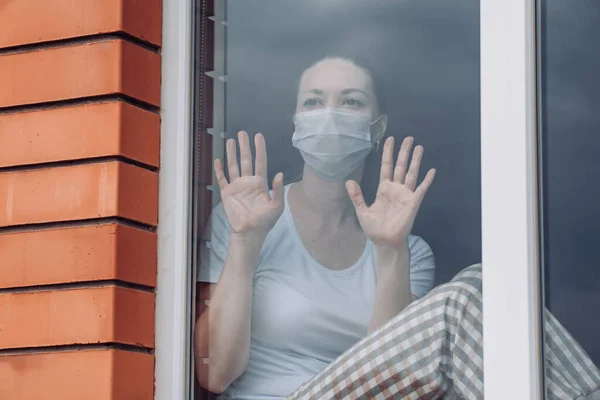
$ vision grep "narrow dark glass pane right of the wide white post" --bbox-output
[538,0,600,398]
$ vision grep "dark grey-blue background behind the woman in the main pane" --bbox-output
[226,0,481,283]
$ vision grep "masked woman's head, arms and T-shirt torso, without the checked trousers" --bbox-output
[199,54,434,398]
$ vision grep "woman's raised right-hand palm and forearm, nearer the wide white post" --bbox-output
[346,137,435,332]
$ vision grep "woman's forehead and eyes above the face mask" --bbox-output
[296,59,377,117]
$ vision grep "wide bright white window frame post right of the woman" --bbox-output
[480,0,543,400]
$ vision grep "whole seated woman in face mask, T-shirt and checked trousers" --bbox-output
[195,58,600,399]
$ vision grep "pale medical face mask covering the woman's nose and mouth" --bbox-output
[292,108,374,181]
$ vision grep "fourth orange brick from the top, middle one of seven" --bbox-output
[0,161,158,227]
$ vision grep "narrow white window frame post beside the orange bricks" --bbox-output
[154,0,194,400]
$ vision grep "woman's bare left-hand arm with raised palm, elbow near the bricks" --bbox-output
[194,132,284,393]
